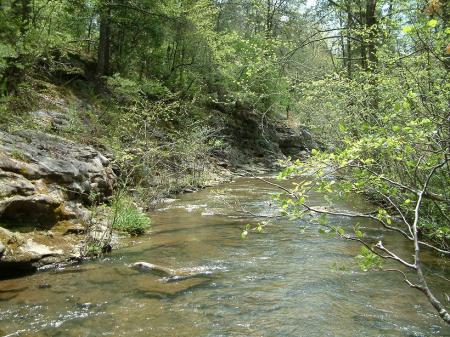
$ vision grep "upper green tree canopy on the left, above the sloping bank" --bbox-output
[0,0,327,127]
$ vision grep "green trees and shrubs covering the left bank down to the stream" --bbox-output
[0,0,324,200]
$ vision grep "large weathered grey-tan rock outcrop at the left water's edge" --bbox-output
[0,121,116,277]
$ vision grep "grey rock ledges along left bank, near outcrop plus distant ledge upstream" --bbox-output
[0,111,315,278]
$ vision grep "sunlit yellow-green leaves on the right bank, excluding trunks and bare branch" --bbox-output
[279,2,450,248]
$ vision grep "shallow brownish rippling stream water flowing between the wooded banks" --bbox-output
[0,178,450,337]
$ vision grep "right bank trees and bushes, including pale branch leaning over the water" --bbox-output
[270,1,450,323]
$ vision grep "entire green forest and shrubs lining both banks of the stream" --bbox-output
[0,0,450,330]
